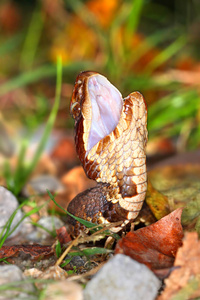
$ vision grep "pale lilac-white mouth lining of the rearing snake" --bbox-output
[87,75,123,151]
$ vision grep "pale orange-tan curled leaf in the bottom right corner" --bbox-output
[157,232,200,300]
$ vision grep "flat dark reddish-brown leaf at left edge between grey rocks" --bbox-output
[0,244,54,259]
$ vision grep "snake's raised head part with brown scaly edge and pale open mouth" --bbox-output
[70,71,123,153]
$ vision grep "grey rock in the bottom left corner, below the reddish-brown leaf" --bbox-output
[0,265,37,300]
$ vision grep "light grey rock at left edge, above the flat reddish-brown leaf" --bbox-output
[0,186,23,237]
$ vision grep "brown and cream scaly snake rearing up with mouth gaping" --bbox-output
[67,71,148,236]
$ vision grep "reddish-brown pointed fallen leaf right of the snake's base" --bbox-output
[115,208,183,270]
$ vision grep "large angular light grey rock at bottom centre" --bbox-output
[84,254,161,300]
